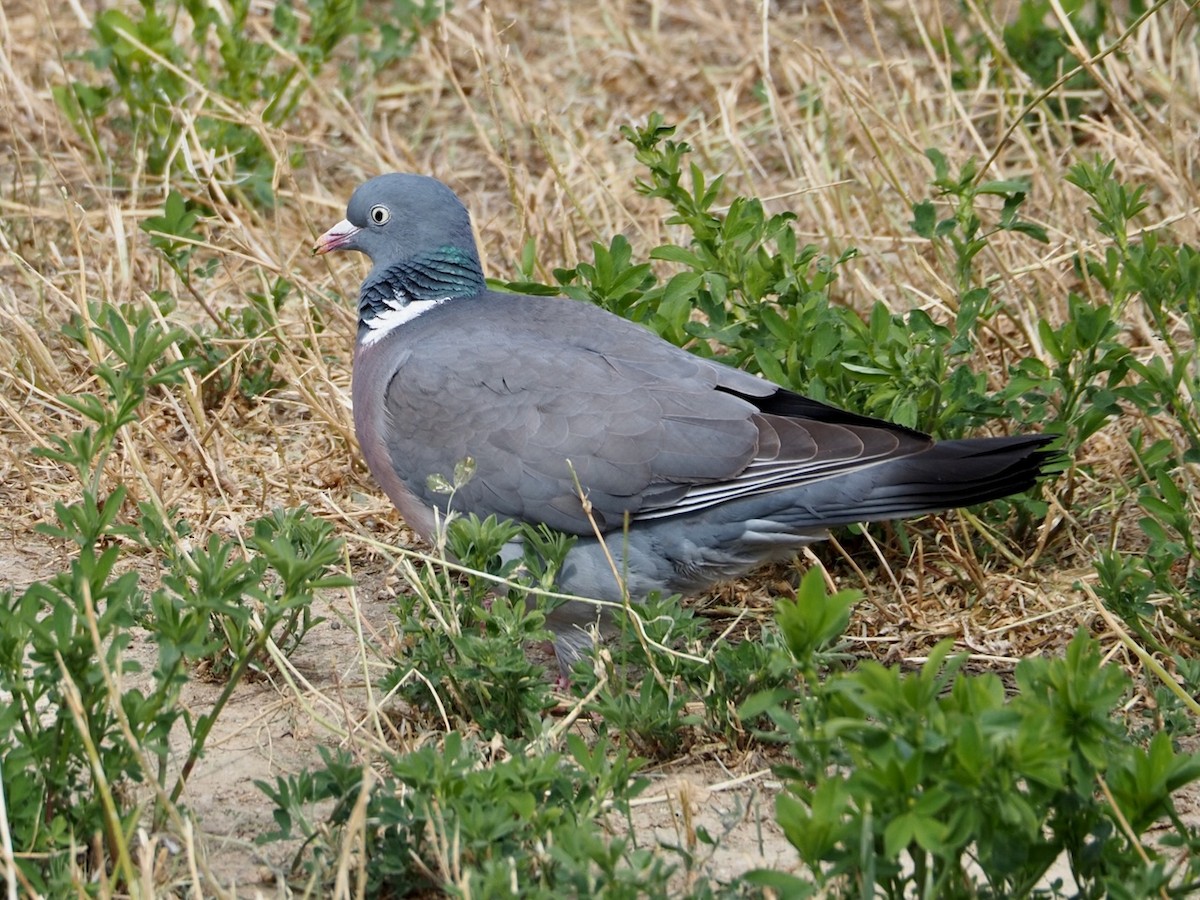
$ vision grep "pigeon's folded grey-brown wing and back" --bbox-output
[384,295,930,534]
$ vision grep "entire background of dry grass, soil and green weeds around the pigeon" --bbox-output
[0,0,1200,896]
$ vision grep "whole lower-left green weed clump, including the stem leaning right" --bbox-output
[0,305,348,896]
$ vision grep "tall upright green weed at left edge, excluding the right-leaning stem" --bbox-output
[0,306,188,886]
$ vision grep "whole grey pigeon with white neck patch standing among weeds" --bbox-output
[313,173,1060,677]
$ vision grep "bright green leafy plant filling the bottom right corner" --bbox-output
[744,581,1200,896]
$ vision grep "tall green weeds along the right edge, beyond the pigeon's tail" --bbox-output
[1041,160,1200,672]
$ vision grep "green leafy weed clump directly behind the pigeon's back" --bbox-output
[537,116,1060,448]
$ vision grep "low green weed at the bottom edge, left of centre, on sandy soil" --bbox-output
[259,732,671,896]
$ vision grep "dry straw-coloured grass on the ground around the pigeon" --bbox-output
[0,0,1200,895]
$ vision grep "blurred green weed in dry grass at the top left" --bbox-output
[54,0,443,205]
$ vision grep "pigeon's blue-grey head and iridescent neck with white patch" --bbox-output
[313,173,487,341]
